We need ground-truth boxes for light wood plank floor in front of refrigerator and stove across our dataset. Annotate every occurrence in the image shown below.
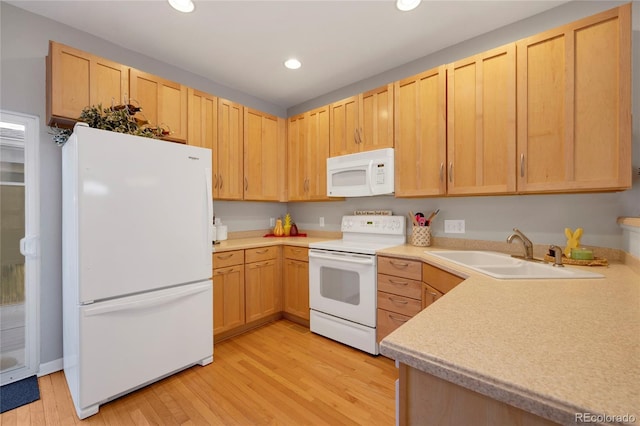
[0,320,398,426]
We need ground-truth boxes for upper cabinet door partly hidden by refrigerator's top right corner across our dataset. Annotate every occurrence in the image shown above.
[187,88,218,198]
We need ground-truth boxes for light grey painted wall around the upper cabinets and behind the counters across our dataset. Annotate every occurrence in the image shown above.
[0,1,640,363]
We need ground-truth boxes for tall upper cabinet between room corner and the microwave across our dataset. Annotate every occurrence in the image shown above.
[287,106,329,201]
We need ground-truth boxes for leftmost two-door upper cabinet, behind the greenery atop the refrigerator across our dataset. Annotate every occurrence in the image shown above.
[47,41,129,126]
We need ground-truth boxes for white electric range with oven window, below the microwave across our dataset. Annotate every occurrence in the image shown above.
[309,216,406,355]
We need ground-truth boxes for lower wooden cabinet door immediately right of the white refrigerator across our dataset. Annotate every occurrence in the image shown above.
[213,265,245,336]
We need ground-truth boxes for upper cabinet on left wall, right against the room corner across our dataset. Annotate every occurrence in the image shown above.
[244,107,286,201]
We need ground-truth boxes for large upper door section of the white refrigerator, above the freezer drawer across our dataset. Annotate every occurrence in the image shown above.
[63,126,213,303]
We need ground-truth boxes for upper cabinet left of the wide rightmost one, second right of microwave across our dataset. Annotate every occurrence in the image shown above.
[447,43,516,195]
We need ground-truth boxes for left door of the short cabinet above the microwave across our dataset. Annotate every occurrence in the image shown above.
[329,96,361,157]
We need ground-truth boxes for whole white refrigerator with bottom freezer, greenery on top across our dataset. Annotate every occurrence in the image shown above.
[62,123,213,419]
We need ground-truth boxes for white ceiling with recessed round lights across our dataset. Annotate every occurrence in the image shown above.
[7,0,588,108]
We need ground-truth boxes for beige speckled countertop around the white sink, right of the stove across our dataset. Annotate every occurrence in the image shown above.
[378,245,640,424]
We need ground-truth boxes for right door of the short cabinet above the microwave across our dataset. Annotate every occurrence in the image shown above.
[358,84,393,151]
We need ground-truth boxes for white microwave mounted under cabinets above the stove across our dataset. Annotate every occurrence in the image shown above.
[327,148,395,197]
